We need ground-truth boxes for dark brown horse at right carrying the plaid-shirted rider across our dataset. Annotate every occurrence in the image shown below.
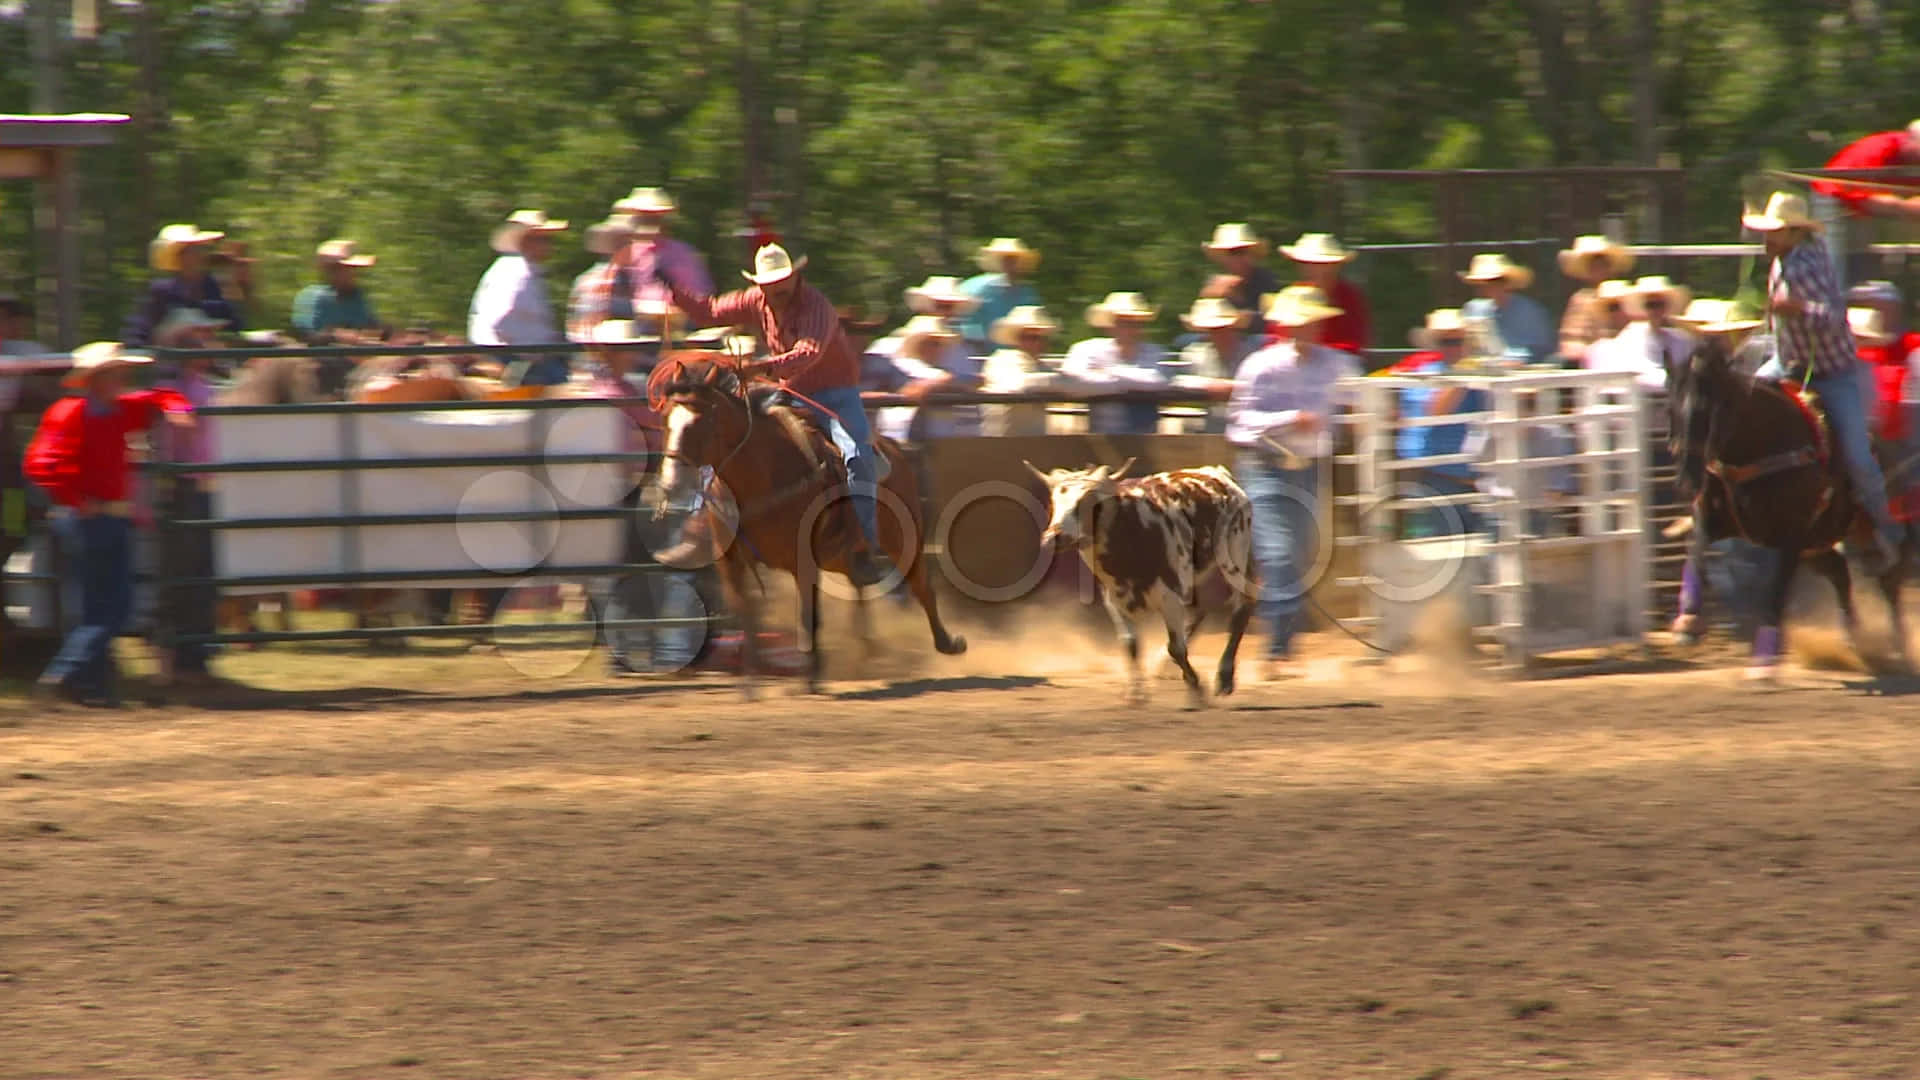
[1668,340,1910,676]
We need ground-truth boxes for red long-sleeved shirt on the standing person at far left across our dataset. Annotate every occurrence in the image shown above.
[21,390,192,507]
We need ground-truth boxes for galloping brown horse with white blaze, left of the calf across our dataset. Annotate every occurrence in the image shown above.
[647,352,966,696]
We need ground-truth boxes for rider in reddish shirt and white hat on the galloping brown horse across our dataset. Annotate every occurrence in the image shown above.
[666,244,893,586]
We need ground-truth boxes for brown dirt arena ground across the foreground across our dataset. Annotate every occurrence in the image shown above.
[0,611,1920,1080]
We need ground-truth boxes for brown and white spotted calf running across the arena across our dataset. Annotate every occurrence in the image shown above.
[1025,457,1260,707]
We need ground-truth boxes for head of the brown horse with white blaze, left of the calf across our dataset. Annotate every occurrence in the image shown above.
[647,352,751,511]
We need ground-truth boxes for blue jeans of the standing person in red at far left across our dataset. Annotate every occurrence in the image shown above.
[40,513,132,694]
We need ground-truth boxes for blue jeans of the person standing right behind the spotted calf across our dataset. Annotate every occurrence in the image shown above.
[1233,454,1319,659]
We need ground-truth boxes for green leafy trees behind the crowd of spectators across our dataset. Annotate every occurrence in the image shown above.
[0,0,1920,346]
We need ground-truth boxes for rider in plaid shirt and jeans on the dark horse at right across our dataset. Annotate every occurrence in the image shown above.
[1741,192,1901,577]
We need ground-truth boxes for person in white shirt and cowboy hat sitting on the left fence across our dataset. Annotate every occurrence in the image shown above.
[467,209,568,386]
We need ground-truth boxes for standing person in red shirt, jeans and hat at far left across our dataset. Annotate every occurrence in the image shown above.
[25,342,194,705]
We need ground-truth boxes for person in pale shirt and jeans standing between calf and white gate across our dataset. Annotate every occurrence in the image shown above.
[1227,284,1359,678]
